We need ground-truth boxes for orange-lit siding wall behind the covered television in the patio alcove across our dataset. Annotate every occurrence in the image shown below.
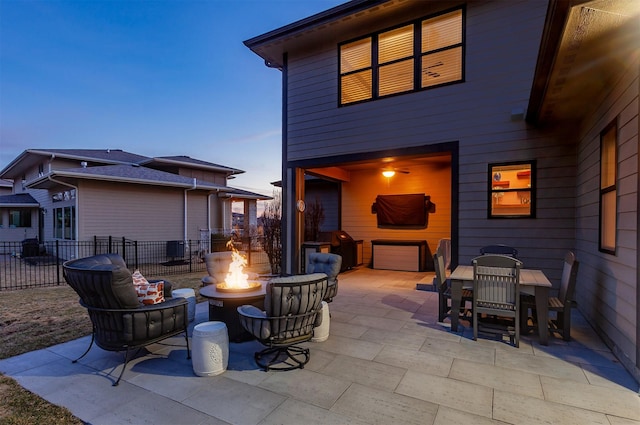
[342,161,451,264]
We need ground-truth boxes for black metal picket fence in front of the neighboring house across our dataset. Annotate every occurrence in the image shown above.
[0,237,269,291]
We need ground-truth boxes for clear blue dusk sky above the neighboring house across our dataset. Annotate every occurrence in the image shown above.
[0,0,346,195]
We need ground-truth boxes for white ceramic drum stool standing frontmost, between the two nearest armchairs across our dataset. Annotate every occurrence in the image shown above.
[191,322,229,376]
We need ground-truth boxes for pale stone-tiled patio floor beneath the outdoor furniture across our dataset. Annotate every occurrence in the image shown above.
[0,267,640,425]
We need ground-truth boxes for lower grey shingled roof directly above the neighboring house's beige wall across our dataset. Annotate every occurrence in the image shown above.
[28,164,232,192]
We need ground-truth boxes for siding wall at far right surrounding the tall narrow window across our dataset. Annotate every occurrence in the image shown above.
[576,55,640,380]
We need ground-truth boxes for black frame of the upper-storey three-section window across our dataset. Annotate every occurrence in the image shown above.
[337,5,467,107]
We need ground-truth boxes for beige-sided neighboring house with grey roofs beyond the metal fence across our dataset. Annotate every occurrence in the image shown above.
[0,149,270,247]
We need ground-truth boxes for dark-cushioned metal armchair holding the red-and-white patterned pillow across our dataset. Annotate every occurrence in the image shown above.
[63,254,191,386]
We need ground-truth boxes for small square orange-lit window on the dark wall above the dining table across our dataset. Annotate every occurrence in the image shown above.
[488,161,536,218]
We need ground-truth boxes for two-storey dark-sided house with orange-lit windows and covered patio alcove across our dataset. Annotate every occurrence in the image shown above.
[245,0,640,380]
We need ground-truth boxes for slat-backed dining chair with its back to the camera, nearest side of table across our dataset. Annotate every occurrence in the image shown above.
[472,254,522,347]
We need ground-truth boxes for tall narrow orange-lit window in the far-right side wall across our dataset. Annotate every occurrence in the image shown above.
[599,122,618,254]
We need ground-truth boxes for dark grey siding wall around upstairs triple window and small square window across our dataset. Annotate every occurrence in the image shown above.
[287,1,576,285]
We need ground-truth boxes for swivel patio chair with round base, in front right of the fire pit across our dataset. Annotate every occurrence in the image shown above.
[238,273,329,371]
